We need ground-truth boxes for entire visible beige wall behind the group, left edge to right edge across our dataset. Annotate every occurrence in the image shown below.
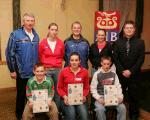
[0,0,150,88]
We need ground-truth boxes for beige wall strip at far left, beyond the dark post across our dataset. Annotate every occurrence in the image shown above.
[0,0,15,88]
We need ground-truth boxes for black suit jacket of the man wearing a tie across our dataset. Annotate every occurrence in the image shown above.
[114,37,145,74]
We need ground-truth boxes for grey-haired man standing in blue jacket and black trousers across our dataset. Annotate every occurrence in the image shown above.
[6,13,39,120]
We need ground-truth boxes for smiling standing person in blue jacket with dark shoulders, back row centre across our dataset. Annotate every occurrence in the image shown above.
[65,21,89,68]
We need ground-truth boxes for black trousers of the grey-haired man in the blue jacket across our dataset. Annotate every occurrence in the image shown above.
[16,75,28,119]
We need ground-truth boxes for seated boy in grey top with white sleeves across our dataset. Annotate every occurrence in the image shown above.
[90,56,126,120]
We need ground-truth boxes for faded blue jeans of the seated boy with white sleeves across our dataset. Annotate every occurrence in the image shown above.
[95,101,126,120]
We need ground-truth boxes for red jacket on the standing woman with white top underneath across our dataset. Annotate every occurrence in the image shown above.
[39,38,64,68]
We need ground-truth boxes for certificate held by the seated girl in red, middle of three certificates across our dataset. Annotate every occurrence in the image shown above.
[68,84,83,105]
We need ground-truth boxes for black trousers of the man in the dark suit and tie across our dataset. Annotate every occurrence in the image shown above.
[118,74,140,119]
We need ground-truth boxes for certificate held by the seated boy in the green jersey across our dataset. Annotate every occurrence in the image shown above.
[32,89,49,113]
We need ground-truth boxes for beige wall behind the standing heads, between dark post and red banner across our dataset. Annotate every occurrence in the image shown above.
[21,0,98,40]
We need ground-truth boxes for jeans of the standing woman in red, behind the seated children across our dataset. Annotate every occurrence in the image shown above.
[46,68,61,112]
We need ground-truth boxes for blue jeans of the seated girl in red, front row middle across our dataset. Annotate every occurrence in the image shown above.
[61,100,89,120]
